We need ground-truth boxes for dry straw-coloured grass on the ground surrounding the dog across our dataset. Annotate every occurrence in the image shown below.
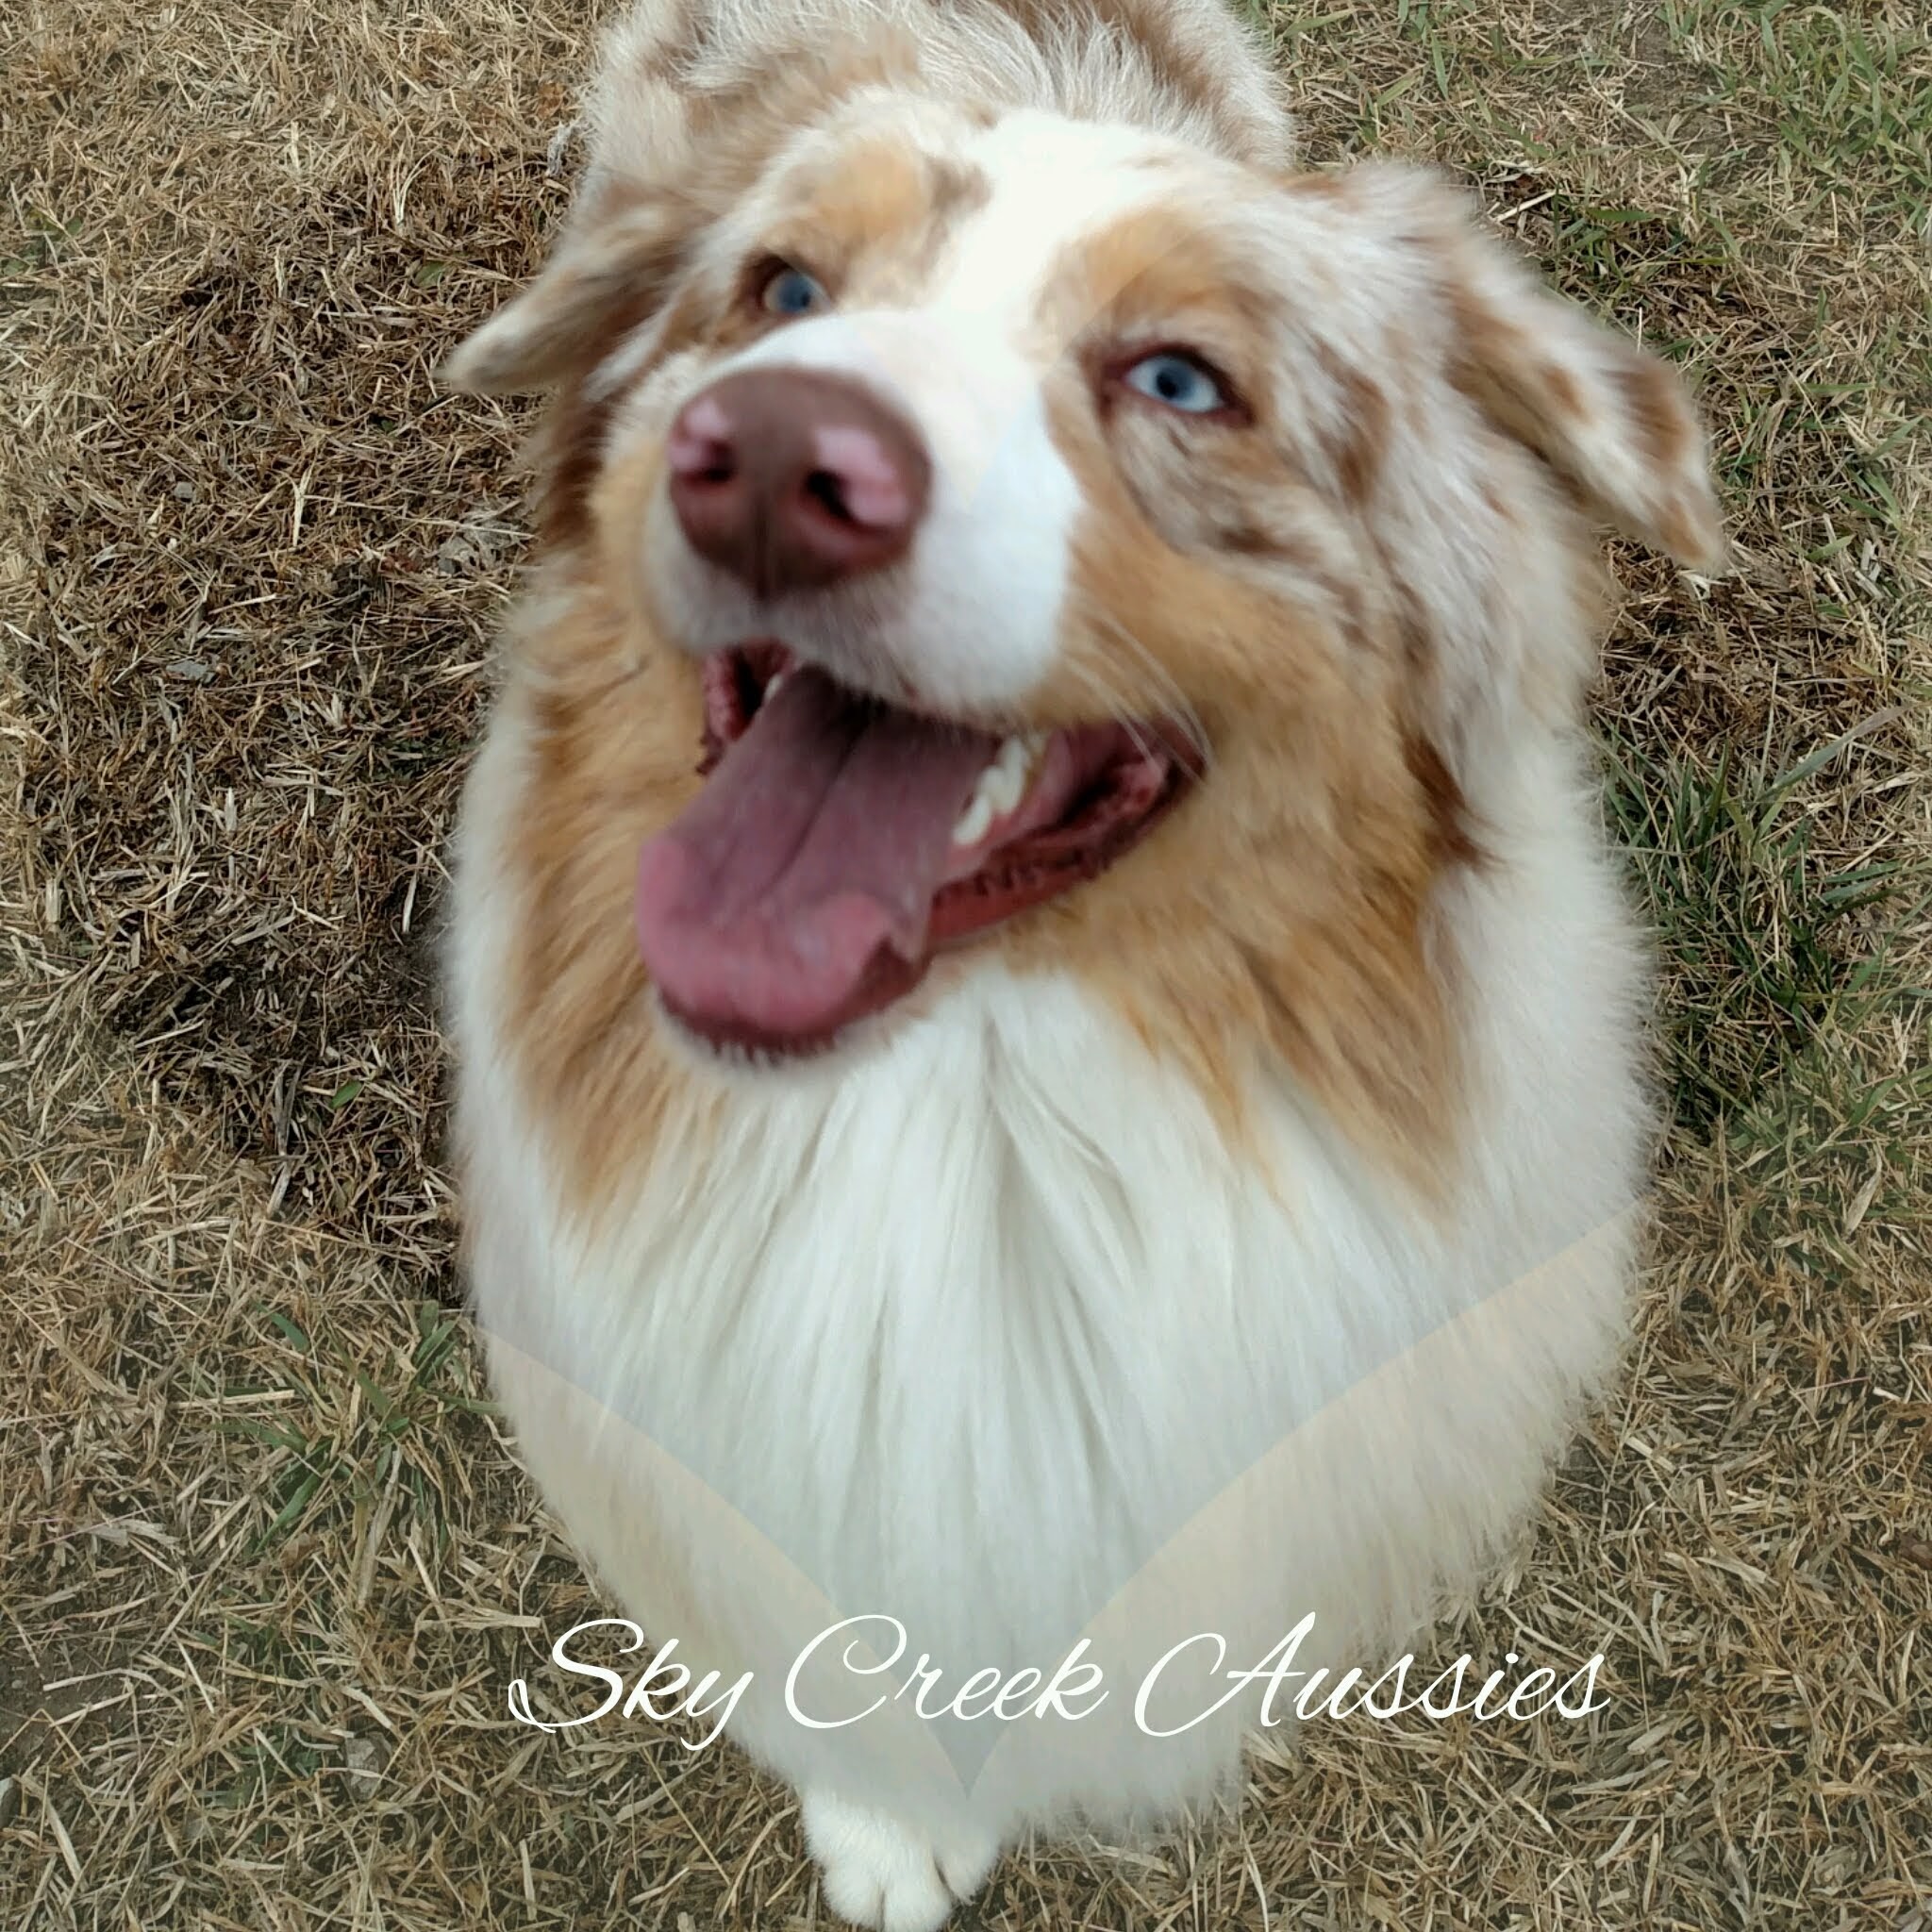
[0,0,1932,1932]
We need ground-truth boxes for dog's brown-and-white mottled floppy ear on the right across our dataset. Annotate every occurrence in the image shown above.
[1360,166,1725,572]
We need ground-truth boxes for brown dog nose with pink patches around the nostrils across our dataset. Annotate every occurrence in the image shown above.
[669,369,931,597]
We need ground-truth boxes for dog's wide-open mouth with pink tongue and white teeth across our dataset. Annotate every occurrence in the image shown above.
[638,643,1200,1053]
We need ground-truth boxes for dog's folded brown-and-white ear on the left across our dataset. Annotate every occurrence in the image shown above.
[437,197,693,396]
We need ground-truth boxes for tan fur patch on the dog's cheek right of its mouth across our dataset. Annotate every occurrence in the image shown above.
[1035,355,1471,1192]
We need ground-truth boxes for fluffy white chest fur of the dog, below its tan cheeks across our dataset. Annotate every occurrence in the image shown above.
[452,699,1641,1836]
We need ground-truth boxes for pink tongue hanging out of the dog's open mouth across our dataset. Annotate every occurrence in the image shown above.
[638,669,999,1047]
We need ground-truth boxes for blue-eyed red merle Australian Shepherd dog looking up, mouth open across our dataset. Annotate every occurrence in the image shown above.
[446,0,1724,1932]
